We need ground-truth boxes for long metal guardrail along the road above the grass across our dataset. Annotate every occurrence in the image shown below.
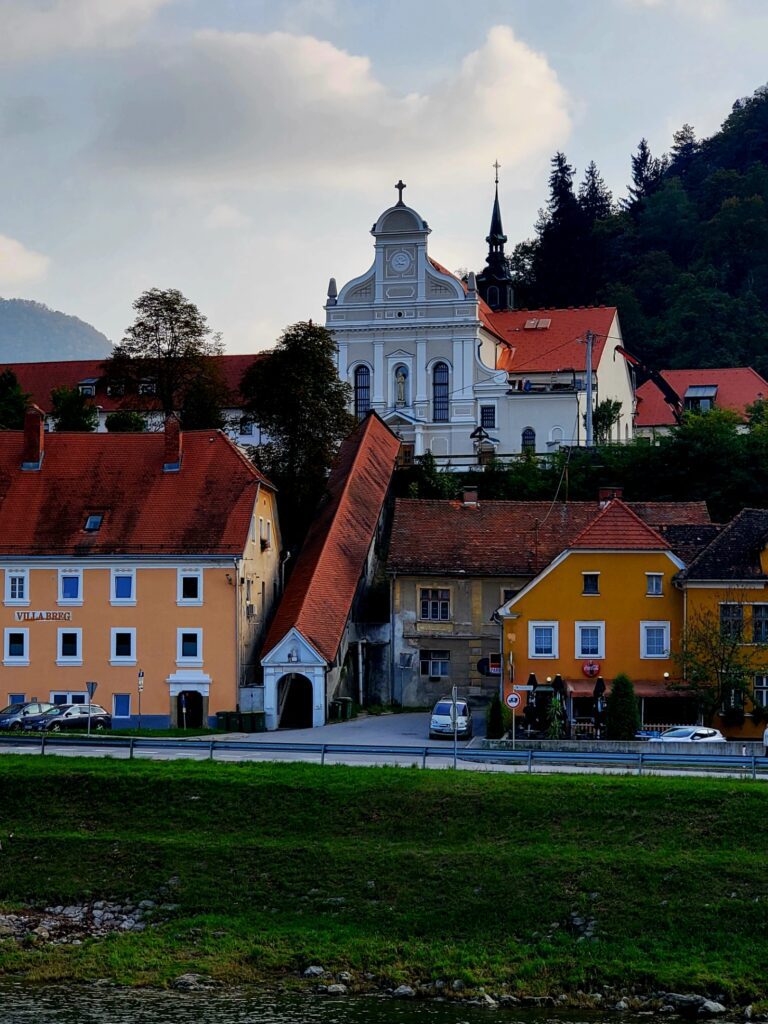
[0,733,768,779]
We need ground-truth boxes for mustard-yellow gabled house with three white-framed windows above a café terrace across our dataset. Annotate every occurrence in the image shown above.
[500,500,689,724]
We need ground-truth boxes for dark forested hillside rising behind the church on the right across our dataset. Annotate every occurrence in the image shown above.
[510,86,768,374]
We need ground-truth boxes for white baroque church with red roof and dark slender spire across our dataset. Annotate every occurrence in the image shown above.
[326,179,634,468]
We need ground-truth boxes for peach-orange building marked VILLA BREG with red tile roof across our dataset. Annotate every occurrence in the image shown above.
[0,408,280,728]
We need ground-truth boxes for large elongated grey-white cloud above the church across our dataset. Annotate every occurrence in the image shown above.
[91,26,570,188]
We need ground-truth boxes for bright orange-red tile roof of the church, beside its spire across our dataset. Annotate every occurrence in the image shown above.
[490,306,621,374]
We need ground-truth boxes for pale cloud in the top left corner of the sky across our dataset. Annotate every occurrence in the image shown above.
[0,0,172,62]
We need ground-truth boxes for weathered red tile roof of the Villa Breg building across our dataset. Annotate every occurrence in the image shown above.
[0,421,271,558]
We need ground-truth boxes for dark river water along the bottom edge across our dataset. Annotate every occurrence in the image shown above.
[0,984,581,1024]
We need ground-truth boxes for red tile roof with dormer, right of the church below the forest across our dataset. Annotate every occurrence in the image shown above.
[635,367,768,427]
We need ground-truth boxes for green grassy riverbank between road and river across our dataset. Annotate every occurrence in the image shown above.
[0,757,768,999]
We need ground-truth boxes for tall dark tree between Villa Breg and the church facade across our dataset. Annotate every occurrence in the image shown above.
[241,321,354,546]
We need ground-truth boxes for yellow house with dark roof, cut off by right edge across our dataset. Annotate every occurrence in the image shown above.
[678,509,768,738]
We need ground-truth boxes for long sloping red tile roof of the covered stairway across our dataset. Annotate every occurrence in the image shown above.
[263,413,400,663]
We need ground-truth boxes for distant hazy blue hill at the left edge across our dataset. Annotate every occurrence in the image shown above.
[0,299,112,365]
